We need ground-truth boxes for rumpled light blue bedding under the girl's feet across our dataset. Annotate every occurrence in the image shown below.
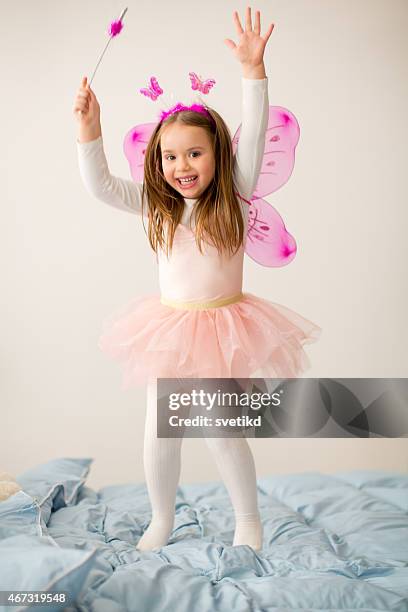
[0,459,408,612]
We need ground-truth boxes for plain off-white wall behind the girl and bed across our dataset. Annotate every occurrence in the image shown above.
[0,0,408,487]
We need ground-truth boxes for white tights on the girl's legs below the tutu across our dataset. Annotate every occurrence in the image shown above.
[137,380,262,550]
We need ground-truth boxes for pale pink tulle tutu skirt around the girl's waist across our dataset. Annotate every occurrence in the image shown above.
[99,293,321,389]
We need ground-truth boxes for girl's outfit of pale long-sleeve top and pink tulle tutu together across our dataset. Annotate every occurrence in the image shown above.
[77,78,321,389]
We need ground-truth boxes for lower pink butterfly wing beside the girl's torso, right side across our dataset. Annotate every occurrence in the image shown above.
[245,198,297,268]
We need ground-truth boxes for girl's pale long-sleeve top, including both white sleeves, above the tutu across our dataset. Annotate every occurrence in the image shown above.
[77,78,269,302]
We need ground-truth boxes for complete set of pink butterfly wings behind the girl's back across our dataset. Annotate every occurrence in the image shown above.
[123,106,300,268]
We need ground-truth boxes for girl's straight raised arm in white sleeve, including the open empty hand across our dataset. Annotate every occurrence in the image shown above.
[225,7,274,199]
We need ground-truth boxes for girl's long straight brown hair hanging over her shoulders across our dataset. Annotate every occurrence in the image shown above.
[142,106,244,257]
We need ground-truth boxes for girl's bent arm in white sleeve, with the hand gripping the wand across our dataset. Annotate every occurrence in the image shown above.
[73,77,147,215]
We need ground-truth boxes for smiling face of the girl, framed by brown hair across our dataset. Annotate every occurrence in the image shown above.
[160,123,215,198]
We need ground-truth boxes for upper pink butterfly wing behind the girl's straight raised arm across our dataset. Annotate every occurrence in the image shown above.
[232,106,300,198]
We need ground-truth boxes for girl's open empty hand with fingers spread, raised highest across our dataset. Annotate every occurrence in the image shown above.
[224,6,275,67]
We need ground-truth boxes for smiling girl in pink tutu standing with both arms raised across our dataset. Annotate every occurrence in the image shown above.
[74,7,320,551]
